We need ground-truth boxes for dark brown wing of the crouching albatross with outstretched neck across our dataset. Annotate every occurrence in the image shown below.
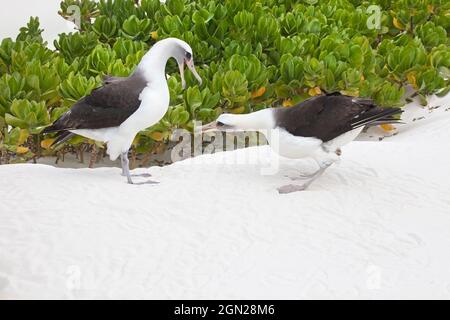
[275,93,402,142]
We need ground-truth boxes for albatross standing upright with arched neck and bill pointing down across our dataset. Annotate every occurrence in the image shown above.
[43,38,202,184]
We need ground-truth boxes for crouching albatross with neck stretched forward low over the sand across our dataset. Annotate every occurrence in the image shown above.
[201,93,402,193]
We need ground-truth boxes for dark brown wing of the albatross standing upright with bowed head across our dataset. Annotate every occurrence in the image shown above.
[43,74,147,133]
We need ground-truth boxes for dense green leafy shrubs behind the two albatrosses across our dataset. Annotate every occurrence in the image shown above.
[0,0,450,162]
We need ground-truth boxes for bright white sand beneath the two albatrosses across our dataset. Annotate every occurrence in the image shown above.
[0,98,450,299]
